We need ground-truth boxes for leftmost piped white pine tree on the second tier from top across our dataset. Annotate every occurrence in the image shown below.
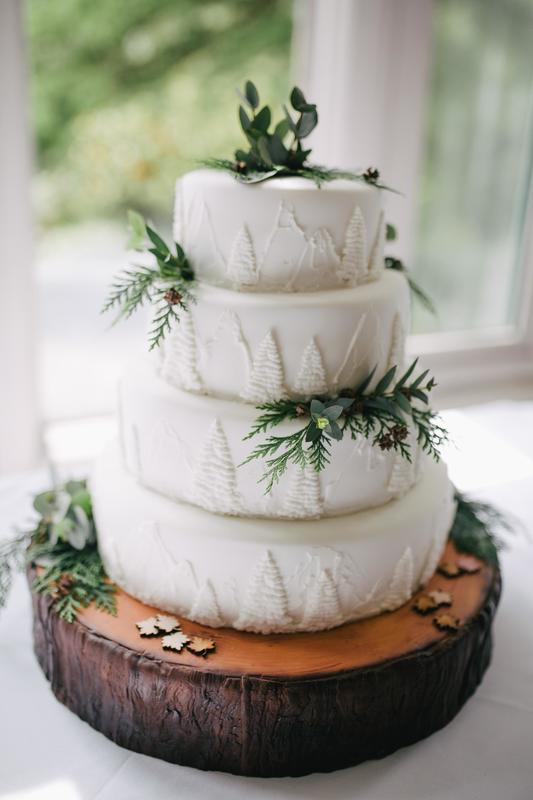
[161,312,202,392]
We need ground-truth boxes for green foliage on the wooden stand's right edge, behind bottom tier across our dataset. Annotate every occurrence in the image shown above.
[450,490,512,566]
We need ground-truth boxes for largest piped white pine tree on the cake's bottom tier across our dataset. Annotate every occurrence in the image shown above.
[235,550,292,633]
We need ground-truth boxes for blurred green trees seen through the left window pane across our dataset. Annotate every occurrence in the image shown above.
[26,0,292,227]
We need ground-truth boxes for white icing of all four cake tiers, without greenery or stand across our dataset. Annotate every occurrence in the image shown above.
[91,169,454,633]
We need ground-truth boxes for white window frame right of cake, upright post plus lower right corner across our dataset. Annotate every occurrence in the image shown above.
[294,0,533,406]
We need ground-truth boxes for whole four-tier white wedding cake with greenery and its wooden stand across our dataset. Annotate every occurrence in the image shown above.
[19,82,501,777]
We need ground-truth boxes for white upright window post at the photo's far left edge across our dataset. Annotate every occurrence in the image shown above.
[0,0,40,474]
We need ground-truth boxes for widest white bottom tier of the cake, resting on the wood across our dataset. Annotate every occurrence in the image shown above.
[91,446,455,633]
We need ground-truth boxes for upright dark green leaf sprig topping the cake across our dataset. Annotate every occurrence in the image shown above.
[202,81,395,191]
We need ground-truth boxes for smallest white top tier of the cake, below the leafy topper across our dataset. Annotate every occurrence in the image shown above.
[174,169,385,292]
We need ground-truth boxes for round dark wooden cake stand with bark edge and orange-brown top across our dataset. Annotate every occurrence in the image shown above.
[33,544,500,776]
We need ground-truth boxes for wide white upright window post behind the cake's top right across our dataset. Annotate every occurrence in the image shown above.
[295,0,433,258]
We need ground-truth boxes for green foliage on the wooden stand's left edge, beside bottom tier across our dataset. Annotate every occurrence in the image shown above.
[0,481,116,622]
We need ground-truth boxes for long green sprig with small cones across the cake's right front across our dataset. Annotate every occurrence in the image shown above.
[242,359,447,493]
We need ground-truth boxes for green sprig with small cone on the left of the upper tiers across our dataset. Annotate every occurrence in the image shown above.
[102,211,194,350]
